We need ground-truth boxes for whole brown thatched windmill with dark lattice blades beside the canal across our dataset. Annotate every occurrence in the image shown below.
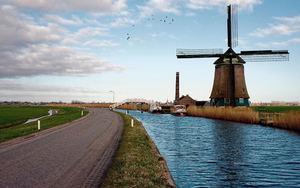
[176,5,289,107]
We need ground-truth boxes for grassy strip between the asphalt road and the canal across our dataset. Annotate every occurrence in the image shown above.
[100,113,173,188]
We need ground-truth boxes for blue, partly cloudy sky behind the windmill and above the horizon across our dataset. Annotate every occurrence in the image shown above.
[0,0,300,103]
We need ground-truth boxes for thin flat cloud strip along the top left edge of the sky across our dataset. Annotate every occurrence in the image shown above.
[0,0,127,12]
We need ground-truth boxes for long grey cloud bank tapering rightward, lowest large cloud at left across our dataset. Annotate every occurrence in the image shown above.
[0,44,125,78]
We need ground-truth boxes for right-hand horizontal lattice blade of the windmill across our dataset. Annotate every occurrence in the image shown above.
[237,50,289,62]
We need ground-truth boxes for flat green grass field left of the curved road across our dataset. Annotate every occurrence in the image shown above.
[0,106,88,143]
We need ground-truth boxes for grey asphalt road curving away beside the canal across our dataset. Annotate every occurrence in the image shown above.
[0,108,124,188]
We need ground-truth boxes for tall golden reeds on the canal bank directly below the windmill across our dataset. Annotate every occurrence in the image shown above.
[187,106,260,123]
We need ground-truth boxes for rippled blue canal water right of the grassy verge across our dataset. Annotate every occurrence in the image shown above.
[118,111,300,187]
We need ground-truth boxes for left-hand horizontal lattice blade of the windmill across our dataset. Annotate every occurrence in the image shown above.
[176,49,223,58]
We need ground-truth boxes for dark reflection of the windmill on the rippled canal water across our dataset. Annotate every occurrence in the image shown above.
[213,121,247,187]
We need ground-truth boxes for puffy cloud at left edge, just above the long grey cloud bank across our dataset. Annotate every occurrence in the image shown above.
[0,5,68,51]
